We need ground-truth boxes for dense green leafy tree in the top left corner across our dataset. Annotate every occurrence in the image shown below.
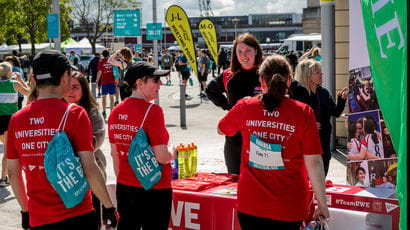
[0,0,71,55]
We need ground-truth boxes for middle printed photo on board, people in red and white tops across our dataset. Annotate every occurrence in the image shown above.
[347,110,385,161]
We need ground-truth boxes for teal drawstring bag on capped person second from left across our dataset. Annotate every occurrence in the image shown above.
[128,104,162,190]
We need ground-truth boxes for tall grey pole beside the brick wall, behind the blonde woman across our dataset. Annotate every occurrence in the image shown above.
[320,0,336,150]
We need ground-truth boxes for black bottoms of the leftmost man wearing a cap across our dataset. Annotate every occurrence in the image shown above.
[30,211,98,230]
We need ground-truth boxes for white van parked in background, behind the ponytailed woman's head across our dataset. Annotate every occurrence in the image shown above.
[276,33,322,53]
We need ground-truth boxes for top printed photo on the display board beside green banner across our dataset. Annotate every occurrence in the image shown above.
[347,66,379,113]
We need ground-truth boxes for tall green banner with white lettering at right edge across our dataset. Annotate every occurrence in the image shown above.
[362,0,407,229]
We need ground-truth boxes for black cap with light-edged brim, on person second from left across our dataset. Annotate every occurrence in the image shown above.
[124,61,171,87]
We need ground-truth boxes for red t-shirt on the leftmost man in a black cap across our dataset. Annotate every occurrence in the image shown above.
[7,98,93,226]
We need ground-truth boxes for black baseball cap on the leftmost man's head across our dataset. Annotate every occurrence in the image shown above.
[33,50,73,80]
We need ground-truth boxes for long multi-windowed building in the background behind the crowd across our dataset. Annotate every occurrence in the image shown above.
[72,13,303,48]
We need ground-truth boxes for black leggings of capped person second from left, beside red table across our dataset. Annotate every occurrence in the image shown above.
[116,184,172,230]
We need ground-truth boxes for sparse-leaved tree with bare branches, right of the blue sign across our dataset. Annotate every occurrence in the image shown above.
[70,0,141,53]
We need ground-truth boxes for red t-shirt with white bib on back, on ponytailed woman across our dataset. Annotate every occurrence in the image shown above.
[218,97,322,221]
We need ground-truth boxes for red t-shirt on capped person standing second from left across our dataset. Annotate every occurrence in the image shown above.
[108,97,172,189]
